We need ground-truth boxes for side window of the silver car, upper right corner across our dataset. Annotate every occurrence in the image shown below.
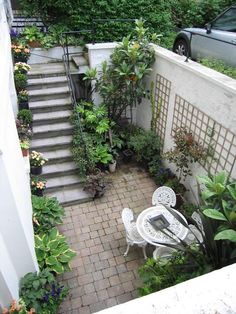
[212,8,236,32]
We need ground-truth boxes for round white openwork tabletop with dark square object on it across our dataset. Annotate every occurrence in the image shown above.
[136,204,188,246]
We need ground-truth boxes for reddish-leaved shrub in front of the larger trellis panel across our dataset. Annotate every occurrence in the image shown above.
[163,128,207,180]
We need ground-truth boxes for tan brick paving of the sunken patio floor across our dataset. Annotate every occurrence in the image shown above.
[59,165,156,314]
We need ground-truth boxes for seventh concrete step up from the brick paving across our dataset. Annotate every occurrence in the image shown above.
[33,110,72,126]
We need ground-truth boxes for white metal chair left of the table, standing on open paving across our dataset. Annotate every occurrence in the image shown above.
[122,208,147,259]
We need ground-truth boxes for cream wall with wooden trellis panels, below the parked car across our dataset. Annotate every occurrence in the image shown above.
[137,45,236,199]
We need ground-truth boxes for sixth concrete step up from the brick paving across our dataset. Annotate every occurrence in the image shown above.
[33,122,73,139]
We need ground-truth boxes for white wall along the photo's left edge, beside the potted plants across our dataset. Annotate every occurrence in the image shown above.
[0,0,38,307]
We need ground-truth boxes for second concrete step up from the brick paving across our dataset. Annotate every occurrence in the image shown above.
[47,174,84,192]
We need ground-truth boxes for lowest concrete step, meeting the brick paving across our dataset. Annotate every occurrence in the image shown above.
[45,187,93,207]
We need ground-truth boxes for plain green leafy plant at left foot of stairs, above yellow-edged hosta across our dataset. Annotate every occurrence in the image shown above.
[32,195,65,234]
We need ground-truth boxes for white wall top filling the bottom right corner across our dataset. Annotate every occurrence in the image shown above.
[98,264,236,314]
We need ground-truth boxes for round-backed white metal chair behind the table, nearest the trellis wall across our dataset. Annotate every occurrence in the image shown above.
[152,186,176,207]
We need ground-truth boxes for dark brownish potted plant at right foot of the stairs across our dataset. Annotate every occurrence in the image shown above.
[84,168,106,199]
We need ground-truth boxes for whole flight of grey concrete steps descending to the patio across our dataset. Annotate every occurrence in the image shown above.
[28,62,92,206]
